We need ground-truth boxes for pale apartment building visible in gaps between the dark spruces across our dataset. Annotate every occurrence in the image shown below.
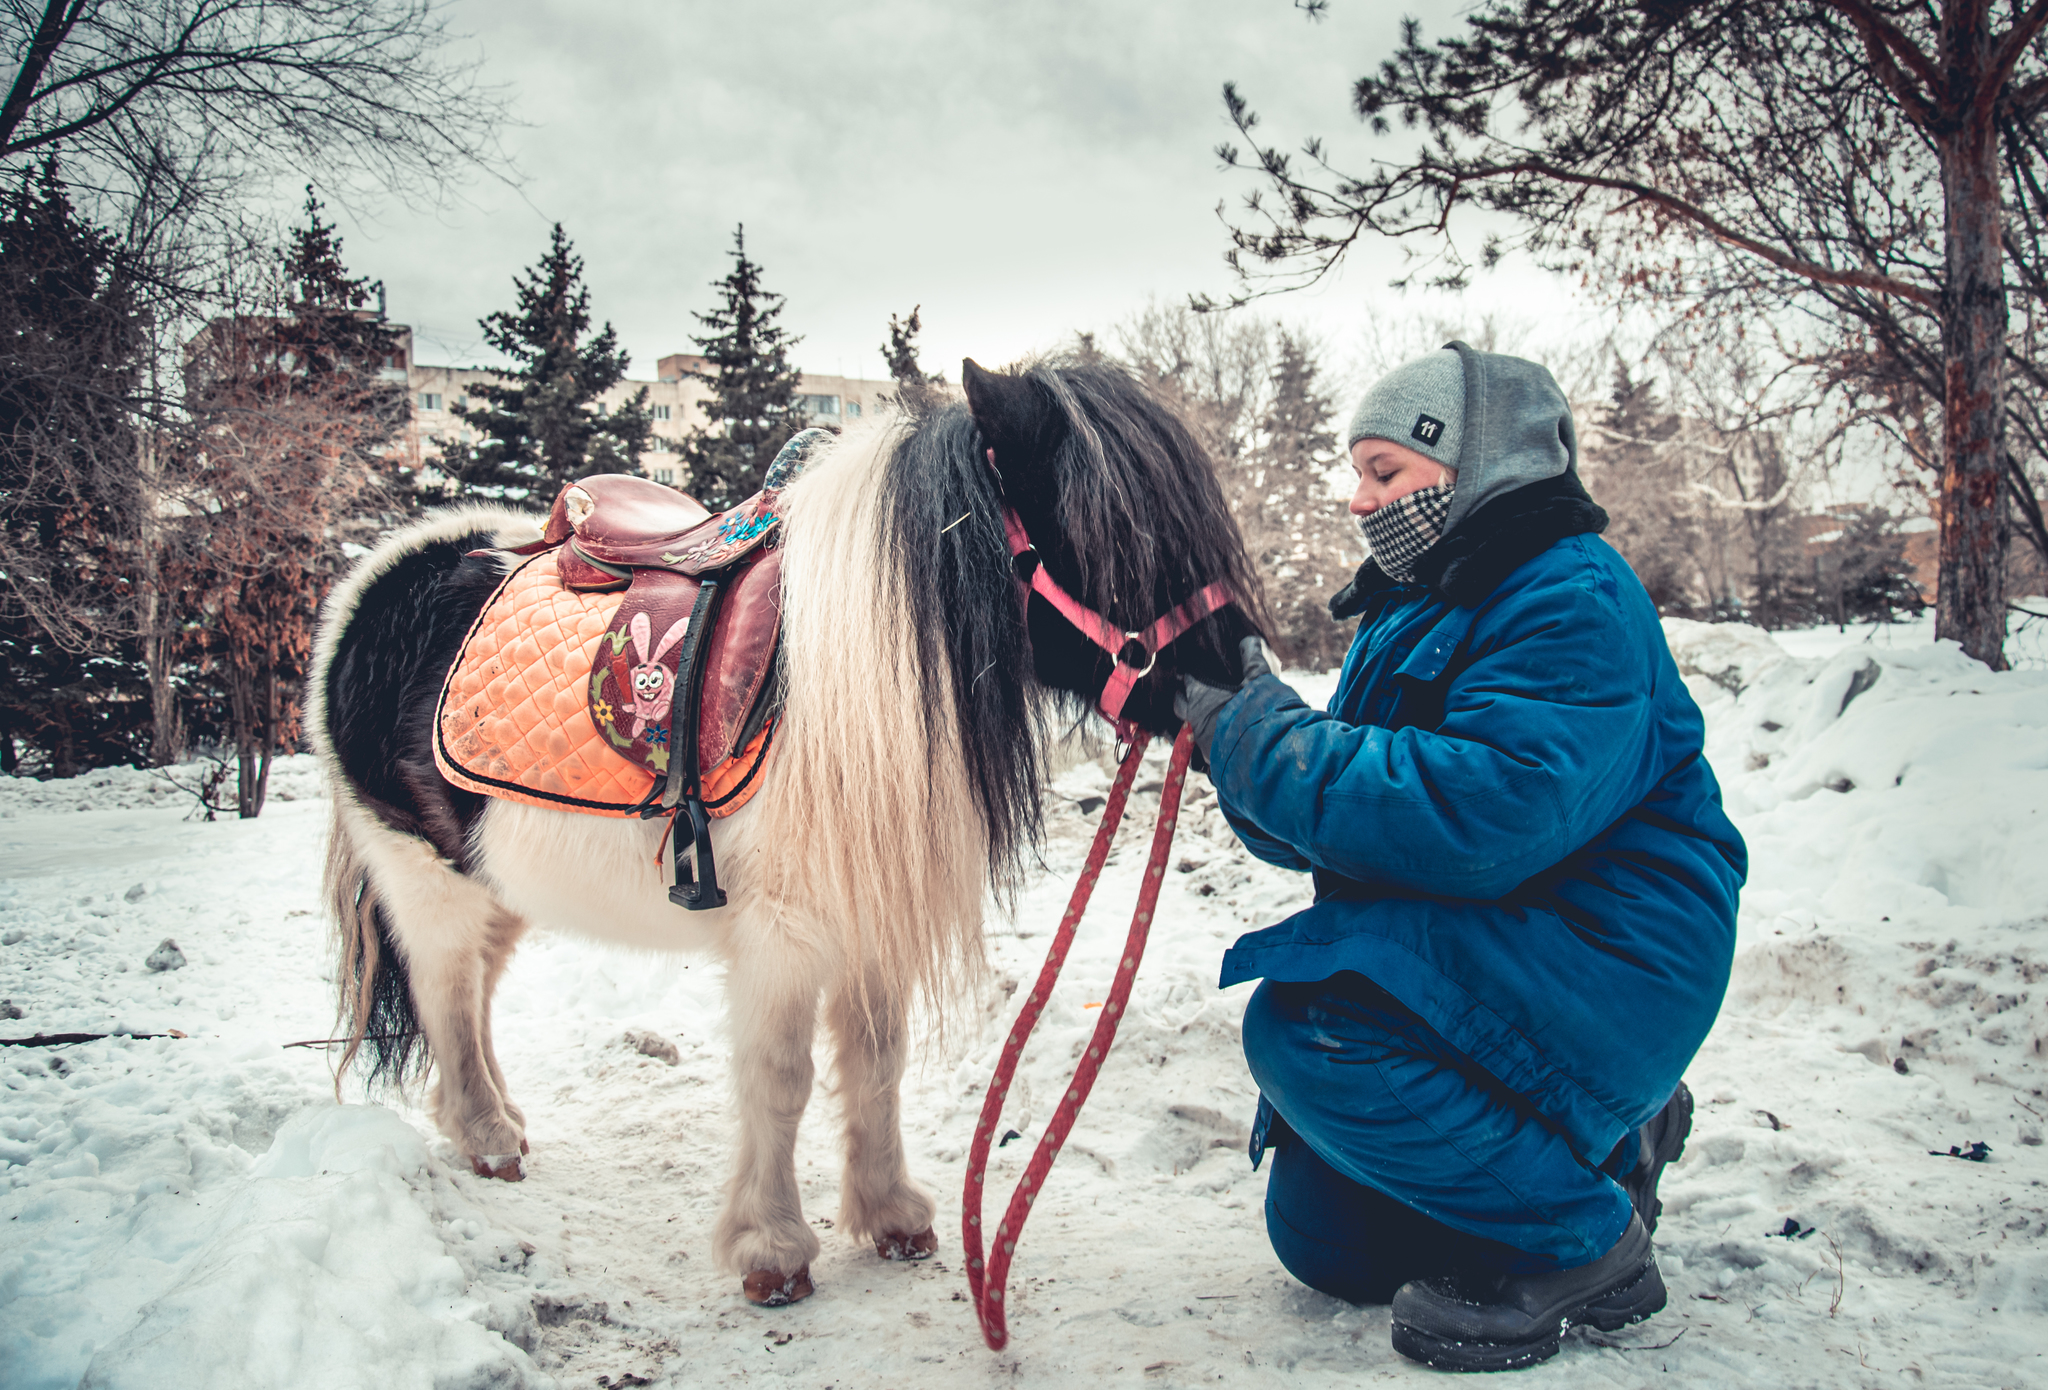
[391,328,895,487]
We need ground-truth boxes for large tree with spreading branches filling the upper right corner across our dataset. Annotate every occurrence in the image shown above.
[1221,0,2048,665]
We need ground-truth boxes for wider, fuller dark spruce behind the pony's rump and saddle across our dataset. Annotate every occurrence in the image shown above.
[438,223,653,504]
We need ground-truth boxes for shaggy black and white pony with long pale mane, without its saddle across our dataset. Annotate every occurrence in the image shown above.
[309,360,1260,1302]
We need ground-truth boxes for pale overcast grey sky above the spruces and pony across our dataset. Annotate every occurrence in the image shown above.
[327,0,1597,391]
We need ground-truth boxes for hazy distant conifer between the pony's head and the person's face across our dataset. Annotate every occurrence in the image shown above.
[1225,328,1364,667]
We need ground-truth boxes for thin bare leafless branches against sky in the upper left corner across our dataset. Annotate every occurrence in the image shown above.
[0,0,502,217]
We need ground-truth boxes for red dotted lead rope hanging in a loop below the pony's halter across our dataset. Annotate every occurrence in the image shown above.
[961,727,1190,1351]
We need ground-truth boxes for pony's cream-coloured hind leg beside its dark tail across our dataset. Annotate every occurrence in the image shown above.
[362,827,526,1181]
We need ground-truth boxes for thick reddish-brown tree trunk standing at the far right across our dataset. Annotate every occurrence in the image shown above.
[1933,0,2007,671]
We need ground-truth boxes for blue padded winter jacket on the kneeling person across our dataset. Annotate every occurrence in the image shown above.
[1210,345,1747,1163]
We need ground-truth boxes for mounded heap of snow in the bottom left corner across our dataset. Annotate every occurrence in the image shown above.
[0,1089,545,1390]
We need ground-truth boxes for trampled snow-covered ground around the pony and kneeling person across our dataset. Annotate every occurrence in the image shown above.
[0,622,2048,1390]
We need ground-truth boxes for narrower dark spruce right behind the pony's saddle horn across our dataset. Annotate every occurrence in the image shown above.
[682,225,807,512]
